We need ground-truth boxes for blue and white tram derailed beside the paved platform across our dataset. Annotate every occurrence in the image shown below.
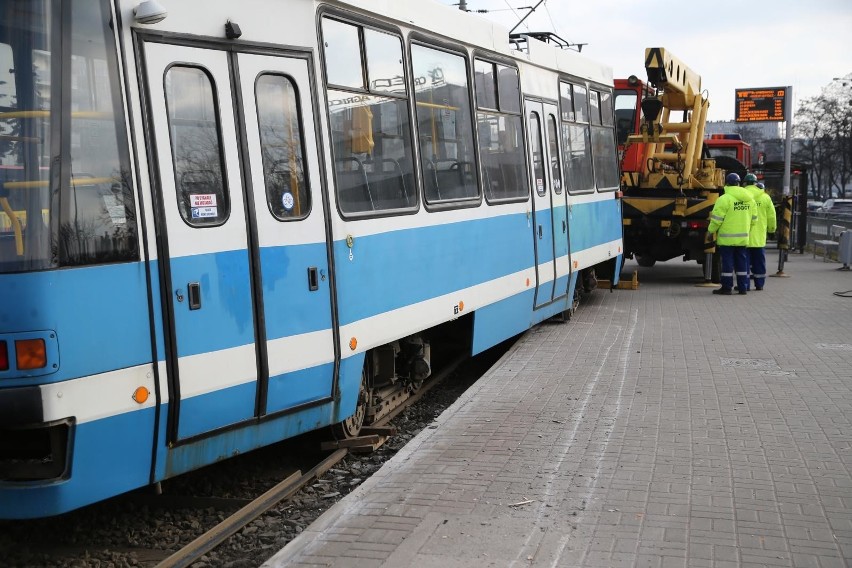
[0,0,622,519]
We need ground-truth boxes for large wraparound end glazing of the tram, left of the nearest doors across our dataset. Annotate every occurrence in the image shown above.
[0,0,139,272]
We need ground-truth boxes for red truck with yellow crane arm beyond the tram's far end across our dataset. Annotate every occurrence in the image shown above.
[615,47,750,272]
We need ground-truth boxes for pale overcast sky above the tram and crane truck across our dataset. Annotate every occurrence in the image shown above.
[438,0,852,120]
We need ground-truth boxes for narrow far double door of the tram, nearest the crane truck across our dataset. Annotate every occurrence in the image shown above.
[525,99,570,307]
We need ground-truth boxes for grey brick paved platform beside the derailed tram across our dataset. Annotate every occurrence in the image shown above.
[264,255,852,568]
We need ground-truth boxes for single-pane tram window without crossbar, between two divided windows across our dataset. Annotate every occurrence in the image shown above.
[411,45,479,203]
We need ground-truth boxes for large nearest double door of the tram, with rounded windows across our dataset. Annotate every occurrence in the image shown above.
[144,43,334,441]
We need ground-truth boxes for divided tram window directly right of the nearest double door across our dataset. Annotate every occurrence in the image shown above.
[322,18,417,215]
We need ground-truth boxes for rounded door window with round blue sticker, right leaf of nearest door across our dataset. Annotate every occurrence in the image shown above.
[255,74,311,221]
